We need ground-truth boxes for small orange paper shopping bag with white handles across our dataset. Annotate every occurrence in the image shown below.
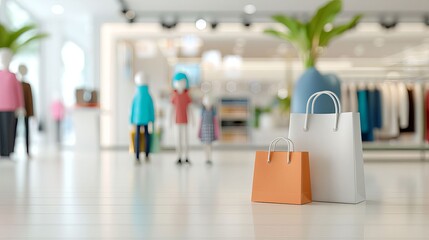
[252,137,311,204]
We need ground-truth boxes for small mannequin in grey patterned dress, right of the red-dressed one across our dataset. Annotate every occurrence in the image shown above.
[198,95,219,165]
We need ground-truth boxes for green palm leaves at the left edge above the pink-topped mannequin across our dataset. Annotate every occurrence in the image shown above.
[0,23,48,54]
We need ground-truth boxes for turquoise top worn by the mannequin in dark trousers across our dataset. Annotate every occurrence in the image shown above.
[130,85,155,126]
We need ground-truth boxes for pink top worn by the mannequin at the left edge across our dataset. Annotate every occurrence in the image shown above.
[0,70,24,112]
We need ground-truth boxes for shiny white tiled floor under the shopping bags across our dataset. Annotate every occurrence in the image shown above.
[0,151,429,240]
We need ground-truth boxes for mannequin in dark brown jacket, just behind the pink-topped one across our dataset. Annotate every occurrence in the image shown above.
[15,64,34,157]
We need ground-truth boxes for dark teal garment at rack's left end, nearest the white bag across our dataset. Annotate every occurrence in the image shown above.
[357,90,374,141]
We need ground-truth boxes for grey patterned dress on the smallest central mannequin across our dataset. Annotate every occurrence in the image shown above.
[198,107,219,144]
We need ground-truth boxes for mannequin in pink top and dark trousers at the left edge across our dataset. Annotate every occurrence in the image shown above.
[0,48,25,157]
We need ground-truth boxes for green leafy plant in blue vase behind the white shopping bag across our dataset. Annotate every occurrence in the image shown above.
[265,0,362,113]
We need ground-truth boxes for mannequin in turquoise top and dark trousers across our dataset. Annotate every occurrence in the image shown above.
[130,71,155,162]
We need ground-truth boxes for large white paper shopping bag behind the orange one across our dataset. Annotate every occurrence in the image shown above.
[289,91,365,203]
